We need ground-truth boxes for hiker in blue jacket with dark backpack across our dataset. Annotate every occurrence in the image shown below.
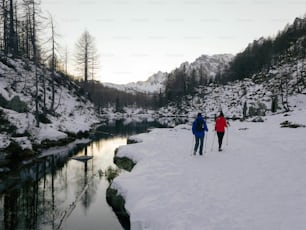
[192,113,208,155]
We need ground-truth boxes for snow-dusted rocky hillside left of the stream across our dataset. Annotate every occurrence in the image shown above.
[0,58,98,159]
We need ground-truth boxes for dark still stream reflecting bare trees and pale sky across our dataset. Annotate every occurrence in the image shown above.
[0,118,184,230]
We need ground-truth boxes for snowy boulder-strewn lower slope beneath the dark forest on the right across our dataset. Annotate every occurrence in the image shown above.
[158,56,306,118]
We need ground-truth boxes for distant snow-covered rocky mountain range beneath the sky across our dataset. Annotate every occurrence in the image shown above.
[103,54,234,93]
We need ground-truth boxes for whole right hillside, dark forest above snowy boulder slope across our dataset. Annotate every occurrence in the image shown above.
[155,18,306,118]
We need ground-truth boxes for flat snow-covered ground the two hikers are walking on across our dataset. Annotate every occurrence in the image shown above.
[112,109,306,230]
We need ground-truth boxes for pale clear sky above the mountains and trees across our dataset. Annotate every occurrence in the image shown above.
[42,0,306,84]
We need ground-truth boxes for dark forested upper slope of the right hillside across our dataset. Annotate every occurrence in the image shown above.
[216,18,306,82]
